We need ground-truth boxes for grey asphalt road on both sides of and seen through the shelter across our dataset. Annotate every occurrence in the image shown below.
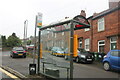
[2,51,120,78]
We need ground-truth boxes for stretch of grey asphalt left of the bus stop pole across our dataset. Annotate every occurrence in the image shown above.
[2,51,32,76]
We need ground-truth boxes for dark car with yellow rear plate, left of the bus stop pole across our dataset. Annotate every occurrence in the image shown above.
[10,47,26,58]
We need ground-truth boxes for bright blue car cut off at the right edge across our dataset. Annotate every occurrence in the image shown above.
[103,50,120,71]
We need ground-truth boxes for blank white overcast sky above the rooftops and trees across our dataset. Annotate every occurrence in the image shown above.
[0,0,109,39]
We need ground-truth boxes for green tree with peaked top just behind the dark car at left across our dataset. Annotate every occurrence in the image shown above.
[7,33,21,47]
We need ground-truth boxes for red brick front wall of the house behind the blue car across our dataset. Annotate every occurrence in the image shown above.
[92,11,118,53]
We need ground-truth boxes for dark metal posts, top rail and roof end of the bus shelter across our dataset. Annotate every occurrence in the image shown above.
[37,15,90,80]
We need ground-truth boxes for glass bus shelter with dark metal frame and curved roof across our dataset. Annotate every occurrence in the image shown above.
[37,15,90,79]
